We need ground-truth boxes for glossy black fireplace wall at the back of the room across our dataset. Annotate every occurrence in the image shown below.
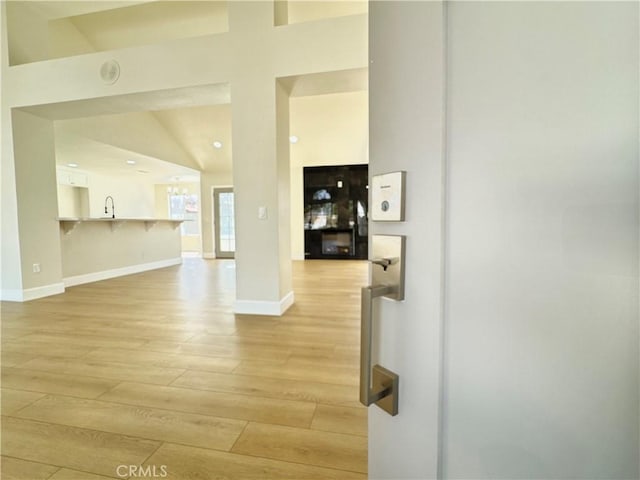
[304,165,369,259]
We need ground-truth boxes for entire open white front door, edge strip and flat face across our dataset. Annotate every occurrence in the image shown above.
[369,2,640,479]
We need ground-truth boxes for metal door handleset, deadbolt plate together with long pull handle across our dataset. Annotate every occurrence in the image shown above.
[360,235,405,415]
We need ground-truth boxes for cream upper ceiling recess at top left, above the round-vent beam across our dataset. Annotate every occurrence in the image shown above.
[8,1,227,65]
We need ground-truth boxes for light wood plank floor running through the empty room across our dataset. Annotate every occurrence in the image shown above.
[1,258,367,480]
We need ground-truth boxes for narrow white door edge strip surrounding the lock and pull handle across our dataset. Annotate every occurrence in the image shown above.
[369,1,443,479]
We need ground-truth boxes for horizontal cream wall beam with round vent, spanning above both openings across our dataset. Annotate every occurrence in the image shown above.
[3,9,366,114]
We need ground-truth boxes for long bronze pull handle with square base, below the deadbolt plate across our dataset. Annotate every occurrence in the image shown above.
[360,284,399,415]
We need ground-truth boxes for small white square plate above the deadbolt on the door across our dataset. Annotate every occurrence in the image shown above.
[370,171,406,222]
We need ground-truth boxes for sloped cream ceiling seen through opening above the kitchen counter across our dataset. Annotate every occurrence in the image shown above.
[56,104,231,183]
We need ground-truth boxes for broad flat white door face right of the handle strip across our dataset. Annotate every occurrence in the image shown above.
[443,2,640,479]
